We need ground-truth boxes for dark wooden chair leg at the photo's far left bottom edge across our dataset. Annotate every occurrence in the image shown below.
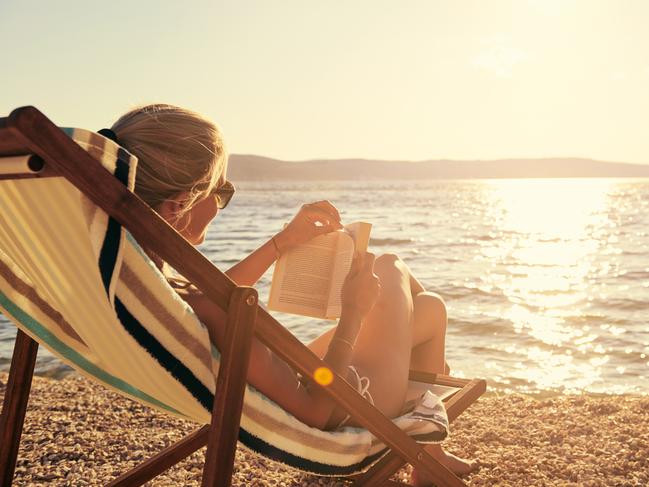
[0,329,38,486]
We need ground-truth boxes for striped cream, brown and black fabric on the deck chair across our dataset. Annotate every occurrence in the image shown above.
[0,129,449,476]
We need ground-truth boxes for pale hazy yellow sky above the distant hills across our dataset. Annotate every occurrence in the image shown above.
[0,0,649,164]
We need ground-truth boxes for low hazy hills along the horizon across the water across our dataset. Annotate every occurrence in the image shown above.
[228,154,649,181]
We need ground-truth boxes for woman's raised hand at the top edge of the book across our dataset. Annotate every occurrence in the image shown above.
[274,201,343,252]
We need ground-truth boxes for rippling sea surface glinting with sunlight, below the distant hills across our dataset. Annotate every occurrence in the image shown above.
[0,179,649,394]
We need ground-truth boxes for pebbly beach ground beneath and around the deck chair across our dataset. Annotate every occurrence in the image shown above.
[0,373,649,486]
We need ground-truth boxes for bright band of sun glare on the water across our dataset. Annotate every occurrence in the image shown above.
[474,179,623,396]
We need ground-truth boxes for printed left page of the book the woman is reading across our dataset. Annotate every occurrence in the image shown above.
[268,232,342,318]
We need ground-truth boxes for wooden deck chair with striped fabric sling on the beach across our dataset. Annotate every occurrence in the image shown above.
[0,107,486,486]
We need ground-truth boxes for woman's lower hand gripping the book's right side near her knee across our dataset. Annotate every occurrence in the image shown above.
[342,252,381,320]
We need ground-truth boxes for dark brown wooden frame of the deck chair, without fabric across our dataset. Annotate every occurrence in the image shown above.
[0,107,486,487]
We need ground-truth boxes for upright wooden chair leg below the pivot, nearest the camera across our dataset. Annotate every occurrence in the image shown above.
[202,287,257,487]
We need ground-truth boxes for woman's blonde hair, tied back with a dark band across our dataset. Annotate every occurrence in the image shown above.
[112,104,228,223]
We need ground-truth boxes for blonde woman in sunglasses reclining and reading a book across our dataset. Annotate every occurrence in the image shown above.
[107,105,474,485]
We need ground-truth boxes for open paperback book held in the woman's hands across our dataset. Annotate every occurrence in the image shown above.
[268,222,372,319]
